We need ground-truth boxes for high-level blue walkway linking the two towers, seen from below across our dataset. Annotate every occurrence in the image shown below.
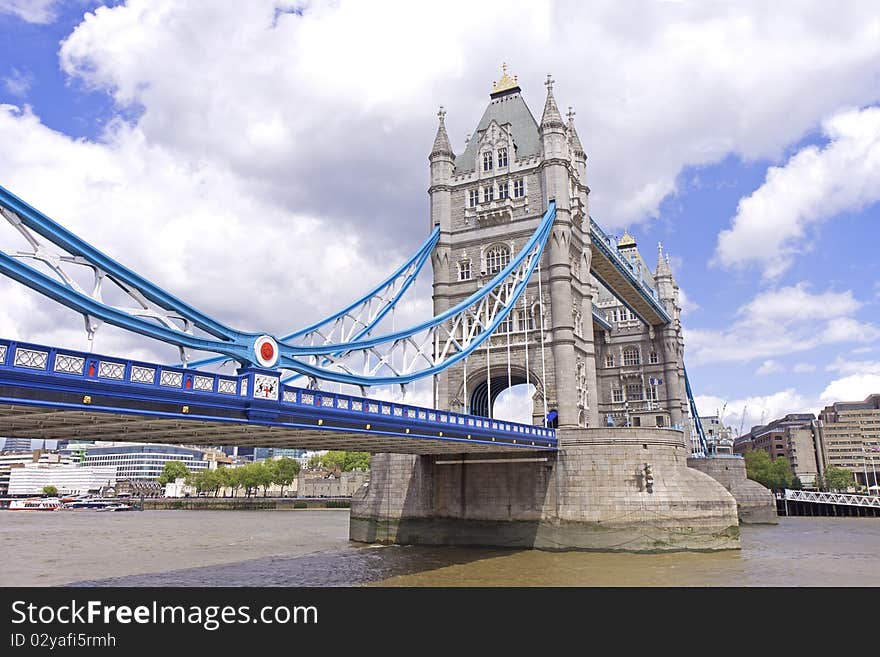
[590,217,672,326]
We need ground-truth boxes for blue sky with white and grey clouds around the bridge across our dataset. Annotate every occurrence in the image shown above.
[0,0,880,440]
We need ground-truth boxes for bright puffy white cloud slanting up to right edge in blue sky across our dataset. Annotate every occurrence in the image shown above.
[716,107,880,277]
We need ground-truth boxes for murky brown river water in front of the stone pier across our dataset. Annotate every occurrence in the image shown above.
[0,509,880,586]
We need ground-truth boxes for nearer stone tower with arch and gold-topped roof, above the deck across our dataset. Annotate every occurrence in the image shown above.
[428,67,599,427]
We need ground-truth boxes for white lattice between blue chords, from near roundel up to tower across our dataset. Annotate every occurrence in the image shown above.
[292,234,544,378]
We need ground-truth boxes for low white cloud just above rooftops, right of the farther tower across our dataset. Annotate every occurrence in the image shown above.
[694,388,818,436]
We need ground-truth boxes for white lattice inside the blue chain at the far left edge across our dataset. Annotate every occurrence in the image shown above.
[0,207,193,362]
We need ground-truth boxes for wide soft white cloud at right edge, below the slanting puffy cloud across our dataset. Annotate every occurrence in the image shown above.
[685,282,880,364]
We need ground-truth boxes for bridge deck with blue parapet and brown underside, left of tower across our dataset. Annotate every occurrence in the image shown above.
[0,341,556,454]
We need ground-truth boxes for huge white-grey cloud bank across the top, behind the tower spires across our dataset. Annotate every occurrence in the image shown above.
[53,0,880,228]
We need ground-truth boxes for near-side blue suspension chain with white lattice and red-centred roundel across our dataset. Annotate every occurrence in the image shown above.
[0,179,556,386]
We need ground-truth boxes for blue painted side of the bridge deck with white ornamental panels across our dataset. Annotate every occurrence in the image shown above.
[0,340,557,450]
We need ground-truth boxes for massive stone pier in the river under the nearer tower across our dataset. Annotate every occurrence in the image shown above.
[350,428,740,552]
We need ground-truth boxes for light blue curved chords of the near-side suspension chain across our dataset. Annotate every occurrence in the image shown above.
[0,182,556,386]
